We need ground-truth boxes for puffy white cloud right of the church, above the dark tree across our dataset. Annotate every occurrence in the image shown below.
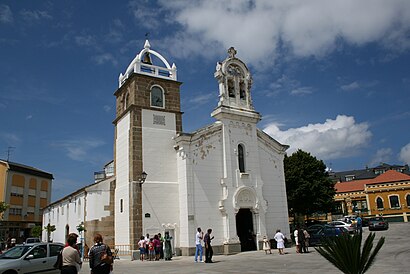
[264,115,372,160]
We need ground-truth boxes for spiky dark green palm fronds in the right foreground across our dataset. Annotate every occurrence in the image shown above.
[315,233,385,274]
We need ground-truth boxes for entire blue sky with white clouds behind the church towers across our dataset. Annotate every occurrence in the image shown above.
[0,0,410,201]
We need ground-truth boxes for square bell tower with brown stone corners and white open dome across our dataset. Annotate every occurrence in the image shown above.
[113,40,182,250]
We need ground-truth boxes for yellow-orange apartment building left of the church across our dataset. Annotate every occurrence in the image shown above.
[0,160,53,243]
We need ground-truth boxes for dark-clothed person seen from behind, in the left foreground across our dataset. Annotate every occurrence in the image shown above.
[88,233,113,274]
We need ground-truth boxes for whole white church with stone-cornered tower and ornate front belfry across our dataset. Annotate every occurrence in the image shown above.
[43,40,289,255]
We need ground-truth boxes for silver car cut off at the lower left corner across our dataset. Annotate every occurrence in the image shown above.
[0,243,64,274]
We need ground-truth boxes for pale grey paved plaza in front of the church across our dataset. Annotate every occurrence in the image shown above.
[80,223,410,274]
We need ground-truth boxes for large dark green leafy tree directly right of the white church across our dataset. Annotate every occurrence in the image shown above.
[284,149,335,219]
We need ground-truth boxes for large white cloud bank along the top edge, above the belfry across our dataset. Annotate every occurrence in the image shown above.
[153,0,410,65]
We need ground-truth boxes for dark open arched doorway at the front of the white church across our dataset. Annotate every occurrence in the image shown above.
[236,208,256,251]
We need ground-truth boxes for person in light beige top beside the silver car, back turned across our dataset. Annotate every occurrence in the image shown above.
[60,233,82,274]
